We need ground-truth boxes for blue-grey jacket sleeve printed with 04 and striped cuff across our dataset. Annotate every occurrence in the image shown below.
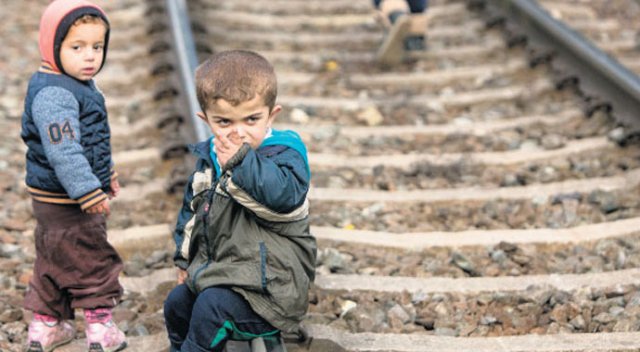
[31,87,107,210]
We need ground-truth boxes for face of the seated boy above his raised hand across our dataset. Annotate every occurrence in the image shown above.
[198,95,282,149]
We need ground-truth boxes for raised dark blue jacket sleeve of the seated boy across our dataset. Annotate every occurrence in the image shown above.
[227,146,310,214]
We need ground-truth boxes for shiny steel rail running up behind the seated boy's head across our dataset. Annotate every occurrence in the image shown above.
[166,0,211,141]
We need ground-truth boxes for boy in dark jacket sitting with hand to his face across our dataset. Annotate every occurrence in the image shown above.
[164,51,316,352]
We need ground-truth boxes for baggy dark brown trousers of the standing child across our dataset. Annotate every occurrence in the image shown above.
[24,200,123,319]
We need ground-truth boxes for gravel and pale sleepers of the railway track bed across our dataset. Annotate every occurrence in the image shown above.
[0,0,640,351]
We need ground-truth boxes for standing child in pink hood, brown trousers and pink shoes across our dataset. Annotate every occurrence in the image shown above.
[21,0,126,352]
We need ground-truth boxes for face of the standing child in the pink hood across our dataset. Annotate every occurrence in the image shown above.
[60,22,107,81]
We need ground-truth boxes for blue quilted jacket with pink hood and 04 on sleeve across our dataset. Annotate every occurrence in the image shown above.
[21,0,115,209]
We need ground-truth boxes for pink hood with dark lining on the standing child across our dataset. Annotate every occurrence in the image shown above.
[38,0,109,73]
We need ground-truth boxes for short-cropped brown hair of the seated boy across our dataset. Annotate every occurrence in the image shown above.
[196,50,278,113]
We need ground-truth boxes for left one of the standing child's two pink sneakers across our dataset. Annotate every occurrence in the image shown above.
[25,320,76,352]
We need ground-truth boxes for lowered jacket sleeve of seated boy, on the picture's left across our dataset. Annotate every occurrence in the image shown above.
[173,172,195,269]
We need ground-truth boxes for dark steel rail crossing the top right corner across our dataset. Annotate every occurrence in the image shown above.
[476,0,640,136]
